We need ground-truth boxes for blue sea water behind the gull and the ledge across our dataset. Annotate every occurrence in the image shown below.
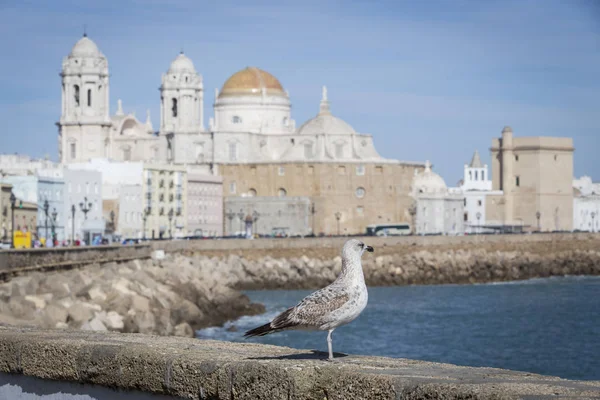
[198,277,600,380]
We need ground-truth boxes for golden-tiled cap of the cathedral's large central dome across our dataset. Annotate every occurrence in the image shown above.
[219,67,287,97]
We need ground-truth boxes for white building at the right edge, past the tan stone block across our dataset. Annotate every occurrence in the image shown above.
[573,176,600,232]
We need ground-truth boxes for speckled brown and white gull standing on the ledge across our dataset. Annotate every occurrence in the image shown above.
[244,239,373,360]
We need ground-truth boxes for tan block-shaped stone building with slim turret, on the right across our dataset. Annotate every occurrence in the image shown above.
[486,126,574,231]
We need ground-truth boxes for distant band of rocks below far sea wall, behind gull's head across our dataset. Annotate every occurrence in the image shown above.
[186,240,600,289]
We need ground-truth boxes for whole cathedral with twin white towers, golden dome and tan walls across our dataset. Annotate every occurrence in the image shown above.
[57,35,425,234]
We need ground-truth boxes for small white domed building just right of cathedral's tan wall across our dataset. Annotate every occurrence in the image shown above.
[412,161,464,235]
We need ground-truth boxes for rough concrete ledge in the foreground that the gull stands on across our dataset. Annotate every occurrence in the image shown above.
[0,327,600,400]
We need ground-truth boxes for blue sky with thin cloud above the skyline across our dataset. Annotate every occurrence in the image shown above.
[0,0,600,185]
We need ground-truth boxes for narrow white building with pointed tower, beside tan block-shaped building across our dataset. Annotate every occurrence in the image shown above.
[460,150,502,233]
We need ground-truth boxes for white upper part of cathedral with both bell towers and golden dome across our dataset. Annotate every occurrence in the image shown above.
[58,36,422,170]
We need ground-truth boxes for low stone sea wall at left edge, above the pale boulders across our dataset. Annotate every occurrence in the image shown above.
[0,244,151,275]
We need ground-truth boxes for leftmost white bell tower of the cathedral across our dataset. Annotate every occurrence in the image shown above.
[57,34,111,163]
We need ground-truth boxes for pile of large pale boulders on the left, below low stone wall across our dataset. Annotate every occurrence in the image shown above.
[0,255,264,337]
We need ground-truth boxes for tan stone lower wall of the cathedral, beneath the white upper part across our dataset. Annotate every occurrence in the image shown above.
[219,163,422,234]
